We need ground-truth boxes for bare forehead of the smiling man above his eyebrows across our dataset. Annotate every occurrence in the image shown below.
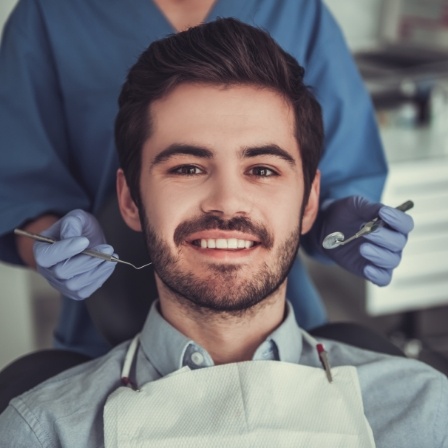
[149,84,299,158]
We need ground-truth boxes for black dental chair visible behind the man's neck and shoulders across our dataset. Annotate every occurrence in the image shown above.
[0,195,405,413]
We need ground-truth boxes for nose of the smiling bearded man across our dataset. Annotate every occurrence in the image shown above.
[201,173,253,219]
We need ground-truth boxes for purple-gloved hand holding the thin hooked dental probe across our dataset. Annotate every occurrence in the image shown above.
[33,210,117,300]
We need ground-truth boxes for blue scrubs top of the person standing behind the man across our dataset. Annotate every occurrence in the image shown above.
[0,0,387,356]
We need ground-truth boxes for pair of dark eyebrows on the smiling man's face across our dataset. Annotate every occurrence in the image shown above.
[151,143,296,168]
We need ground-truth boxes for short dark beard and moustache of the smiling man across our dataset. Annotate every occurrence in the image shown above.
[142,210,301,315]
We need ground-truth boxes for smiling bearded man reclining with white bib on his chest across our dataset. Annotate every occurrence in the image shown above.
[0,19,448,448]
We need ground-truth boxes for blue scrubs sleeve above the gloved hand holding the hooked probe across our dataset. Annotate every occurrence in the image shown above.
[0,1,89,264]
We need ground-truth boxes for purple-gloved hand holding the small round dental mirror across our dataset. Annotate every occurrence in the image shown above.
[317,196,414,286]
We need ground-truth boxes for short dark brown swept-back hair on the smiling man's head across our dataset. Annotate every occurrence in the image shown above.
[115,18,323,205]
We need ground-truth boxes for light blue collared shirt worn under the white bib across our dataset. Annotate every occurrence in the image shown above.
[0,304,448,448]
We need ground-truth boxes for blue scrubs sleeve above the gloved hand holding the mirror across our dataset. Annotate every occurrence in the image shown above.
[303,1,387,256]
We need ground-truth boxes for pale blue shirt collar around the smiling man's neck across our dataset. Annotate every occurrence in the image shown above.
[140,300,302,376]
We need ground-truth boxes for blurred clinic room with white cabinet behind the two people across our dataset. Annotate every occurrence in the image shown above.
[0,0,448,374]
